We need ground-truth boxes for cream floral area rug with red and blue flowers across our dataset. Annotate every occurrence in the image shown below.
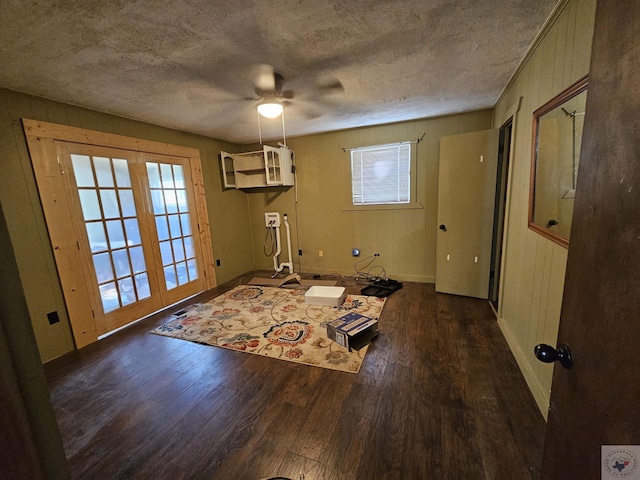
[151,285,385,373]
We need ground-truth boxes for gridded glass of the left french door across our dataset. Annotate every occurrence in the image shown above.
[71,154,151,313]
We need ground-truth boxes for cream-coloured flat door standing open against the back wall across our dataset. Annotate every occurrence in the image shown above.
[436,129,500,298]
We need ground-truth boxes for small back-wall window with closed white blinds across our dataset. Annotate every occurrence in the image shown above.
[351,142,411,205]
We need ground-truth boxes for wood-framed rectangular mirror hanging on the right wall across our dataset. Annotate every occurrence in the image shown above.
[529,76,588,247]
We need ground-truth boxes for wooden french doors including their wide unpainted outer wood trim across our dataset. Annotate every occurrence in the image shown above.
[22,119,216,348]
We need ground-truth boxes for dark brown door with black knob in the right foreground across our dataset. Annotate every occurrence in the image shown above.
[540,1,640,480]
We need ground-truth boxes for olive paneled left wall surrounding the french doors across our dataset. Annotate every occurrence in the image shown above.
[0,90,253,361]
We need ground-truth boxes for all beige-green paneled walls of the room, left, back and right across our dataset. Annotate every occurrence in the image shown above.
[0,4,595,415]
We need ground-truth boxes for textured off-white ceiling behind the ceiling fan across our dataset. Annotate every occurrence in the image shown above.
[0,0,556,143]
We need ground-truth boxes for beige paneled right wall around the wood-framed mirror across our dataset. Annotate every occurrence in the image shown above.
[494,0,596,417]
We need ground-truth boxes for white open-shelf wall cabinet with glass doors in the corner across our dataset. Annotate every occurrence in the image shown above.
[220,145,295,188]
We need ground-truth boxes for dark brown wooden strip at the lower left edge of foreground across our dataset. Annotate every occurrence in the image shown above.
[0,205,69,479]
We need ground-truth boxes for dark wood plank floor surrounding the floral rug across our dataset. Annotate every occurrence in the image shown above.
[46,274,545,480]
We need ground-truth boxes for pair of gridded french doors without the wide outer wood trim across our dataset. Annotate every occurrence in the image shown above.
[56,142,204,335]
